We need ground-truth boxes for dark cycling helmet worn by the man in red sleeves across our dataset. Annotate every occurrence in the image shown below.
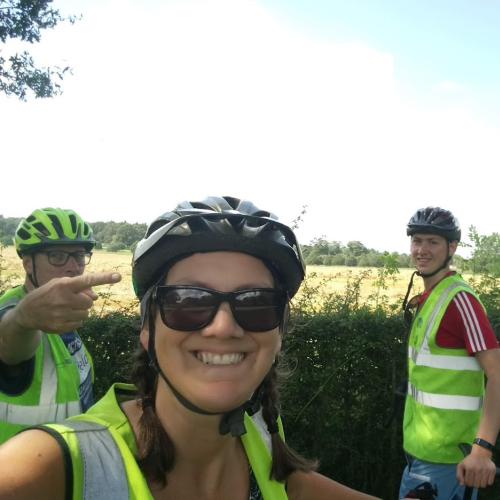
[406,207,461,241]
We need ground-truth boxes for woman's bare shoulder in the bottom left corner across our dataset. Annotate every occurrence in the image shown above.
[0,429,65,500]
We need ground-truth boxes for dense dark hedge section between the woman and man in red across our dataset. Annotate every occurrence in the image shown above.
[283,309,405,498]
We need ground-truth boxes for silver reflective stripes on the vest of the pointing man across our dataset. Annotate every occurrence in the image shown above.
[0,334,81,425]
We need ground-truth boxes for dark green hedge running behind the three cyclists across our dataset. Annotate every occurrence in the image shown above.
[81,276,500,500]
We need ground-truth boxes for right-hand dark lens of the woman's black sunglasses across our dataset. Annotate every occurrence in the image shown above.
[233,290,286,332]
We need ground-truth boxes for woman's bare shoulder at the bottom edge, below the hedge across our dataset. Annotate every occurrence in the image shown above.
[287,471,376,500]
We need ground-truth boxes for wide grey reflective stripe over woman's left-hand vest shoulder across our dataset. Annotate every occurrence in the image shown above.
[64,420,129,500]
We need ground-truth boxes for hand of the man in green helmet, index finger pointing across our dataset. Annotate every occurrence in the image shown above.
[16,272,121,333]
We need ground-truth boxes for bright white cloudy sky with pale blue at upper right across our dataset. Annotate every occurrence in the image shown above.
[0,0,500,252]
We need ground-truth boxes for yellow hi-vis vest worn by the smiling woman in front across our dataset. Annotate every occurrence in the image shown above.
[44,384,288,500]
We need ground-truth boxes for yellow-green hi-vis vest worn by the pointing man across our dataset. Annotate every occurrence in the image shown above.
[0,286,81,444]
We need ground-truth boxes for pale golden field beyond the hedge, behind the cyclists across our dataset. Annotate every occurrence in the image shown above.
[0,246,420,311]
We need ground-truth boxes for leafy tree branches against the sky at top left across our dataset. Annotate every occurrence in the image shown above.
[0,0,75,100]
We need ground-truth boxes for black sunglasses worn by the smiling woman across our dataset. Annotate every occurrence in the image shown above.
[153,285,288,332]
